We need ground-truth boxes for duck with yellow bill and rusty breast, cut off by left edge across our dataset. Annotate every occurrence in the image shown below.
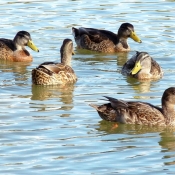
[0,31,39,62]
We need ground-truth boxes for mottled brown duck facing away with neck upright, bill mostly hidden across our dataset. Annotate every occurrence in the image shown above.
[32,39,77,85]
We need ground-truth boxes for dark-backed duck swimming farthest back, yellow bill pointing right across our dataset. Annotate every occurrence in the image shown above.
[72,23,142,53]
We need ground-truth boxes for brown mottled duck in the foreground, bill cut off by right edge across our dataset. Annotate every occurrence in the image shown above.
[90,87,175,126]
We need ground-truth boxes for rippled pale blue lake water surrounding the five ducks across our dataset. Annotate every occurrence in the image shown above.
[0,0,175,175]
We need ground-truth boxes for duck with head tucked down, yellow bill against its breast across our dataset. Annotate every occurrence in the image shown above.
[122,52,163,80]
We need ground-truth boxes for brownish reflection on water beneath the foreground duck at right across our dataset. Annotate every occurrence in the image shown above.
[96,120,175,165]
